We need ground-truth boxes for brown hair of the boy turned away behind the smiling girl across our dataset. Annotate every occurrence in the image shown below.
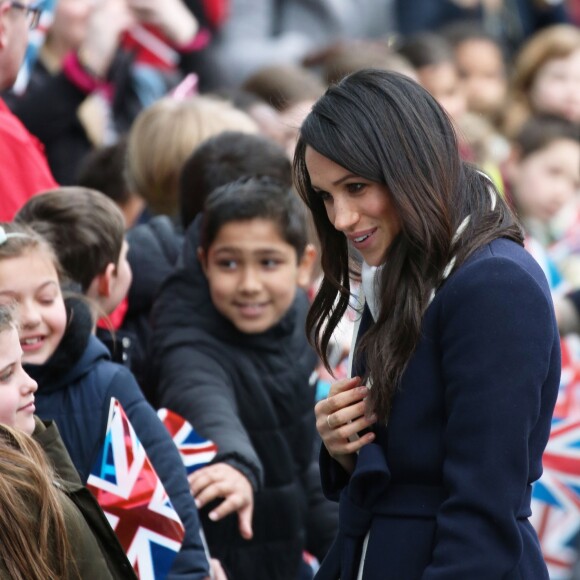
[15,187,125,292]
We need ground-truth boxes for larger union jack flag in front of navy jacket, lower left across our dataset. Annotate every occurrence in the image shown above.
[87,399,185,580]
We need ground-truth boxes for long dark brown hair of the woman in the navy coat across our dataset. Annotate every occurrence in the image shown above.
[294,69,522,419]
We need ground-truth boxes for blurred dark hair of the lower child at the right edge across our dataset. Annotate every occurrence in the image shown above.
[514,115,580,158]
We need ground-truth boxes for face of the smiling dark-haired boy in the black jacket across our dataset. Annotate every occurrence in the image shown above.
[198,219,311,334]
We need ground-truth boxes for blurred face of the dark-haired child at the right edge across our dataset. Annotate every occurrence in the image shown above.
[511,139,580,223]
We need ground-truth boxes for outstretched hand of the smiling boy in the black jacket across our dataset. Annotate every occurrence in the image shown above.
[188,463,254,540]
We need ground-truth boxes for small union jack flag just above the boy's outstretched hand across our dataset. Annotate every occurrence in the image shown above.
[157,409,217,475]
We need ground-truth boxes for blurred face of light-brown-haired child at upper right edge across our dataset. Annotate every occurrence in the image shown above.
[530,49,580,123]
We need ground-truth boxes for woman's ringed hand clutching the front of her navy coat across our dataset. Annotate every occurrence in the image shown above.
[314,377,377,473]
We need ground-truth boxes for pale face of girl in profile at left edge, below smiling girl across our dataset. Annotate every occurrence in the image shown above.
[0,328,38,435]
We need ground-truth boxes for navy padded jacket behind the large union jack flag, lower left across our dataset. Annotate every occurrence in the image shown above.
[25,299,209,580]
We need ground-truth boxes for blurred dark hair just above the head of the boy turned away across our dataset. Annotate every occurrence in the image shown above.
[76,137,131,206]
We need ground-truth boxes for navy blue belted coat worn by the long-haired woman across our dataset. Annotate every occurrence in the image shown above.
[317,239,560,580]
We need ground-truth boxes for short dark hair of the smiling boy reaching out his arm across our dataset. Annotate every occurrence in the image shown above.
[200,177,308,259]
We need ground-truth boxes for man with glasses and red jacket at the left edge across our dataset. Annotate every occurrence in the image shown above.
[0,0,57,221]
